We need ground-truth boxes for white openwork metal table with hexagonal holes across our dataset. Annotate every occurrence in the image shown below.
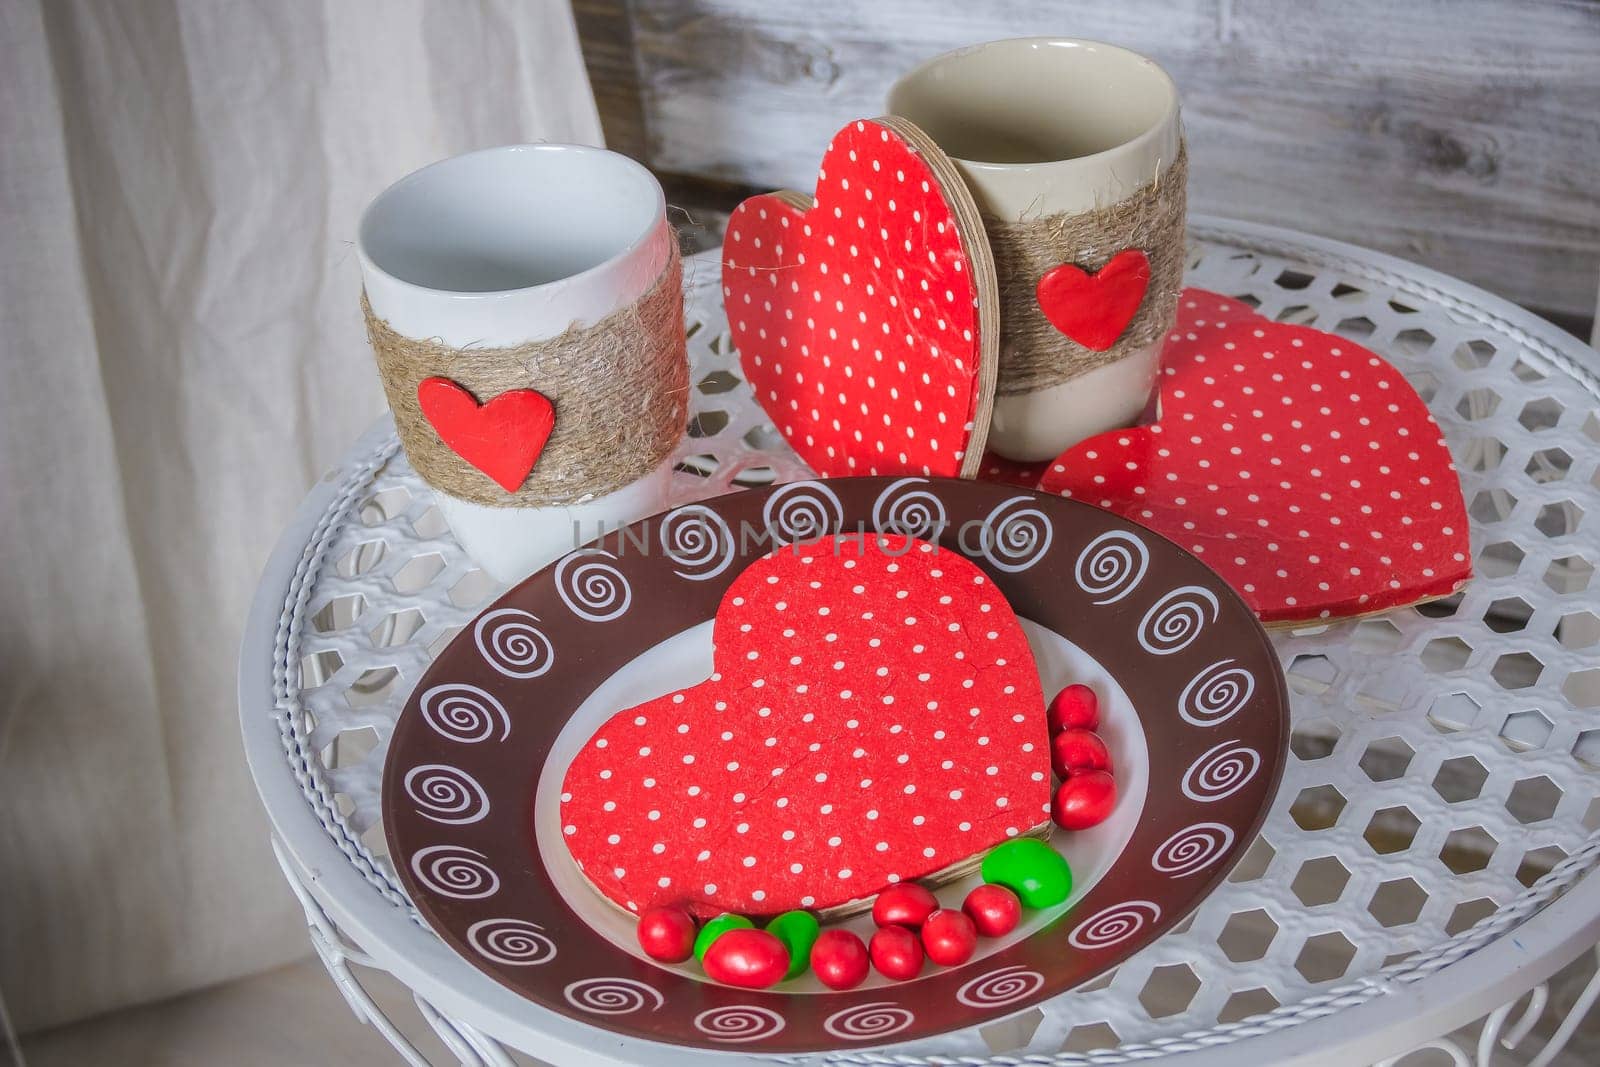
[240,219,1600,1067]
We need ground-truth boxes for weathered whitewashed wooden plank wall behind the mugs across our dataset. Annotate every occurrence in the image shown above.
[574,0,1600,325]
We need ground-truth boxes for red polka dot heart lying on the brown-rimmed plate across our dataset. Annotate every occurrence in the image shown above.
[562,534,1050,915]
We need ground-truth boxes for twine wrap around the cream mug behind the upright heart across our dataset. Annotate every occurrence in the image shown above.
[984,146,1189,397]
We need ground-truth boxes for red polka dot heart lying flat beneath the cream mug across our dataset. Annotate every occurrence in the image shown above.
[1040,290,1472,622]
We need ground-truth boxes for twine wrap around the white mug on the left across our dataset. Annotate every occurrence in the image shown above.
[362,242,688,507]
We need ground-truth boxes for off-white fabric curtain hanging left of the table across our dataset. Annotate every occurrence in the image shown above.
[0,0,600,1030]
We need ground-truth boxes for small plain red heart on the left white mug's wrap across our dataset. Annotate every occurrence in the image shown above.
[416,378,555,493]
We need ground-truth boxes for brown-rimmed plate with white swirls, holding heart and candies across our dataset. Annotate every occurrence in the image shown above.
[382,478,1288,1053]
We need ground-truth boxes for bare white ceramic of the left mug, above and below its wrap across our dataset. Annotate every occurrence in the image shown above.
[357,144,677,582]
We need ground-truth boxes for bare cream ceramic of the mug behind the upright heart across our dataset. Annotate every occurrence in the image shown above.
[888,37,1181,462]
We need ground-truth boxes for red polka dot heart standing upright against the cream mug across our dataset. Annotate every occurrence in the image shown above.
[722,118,1000,477]
